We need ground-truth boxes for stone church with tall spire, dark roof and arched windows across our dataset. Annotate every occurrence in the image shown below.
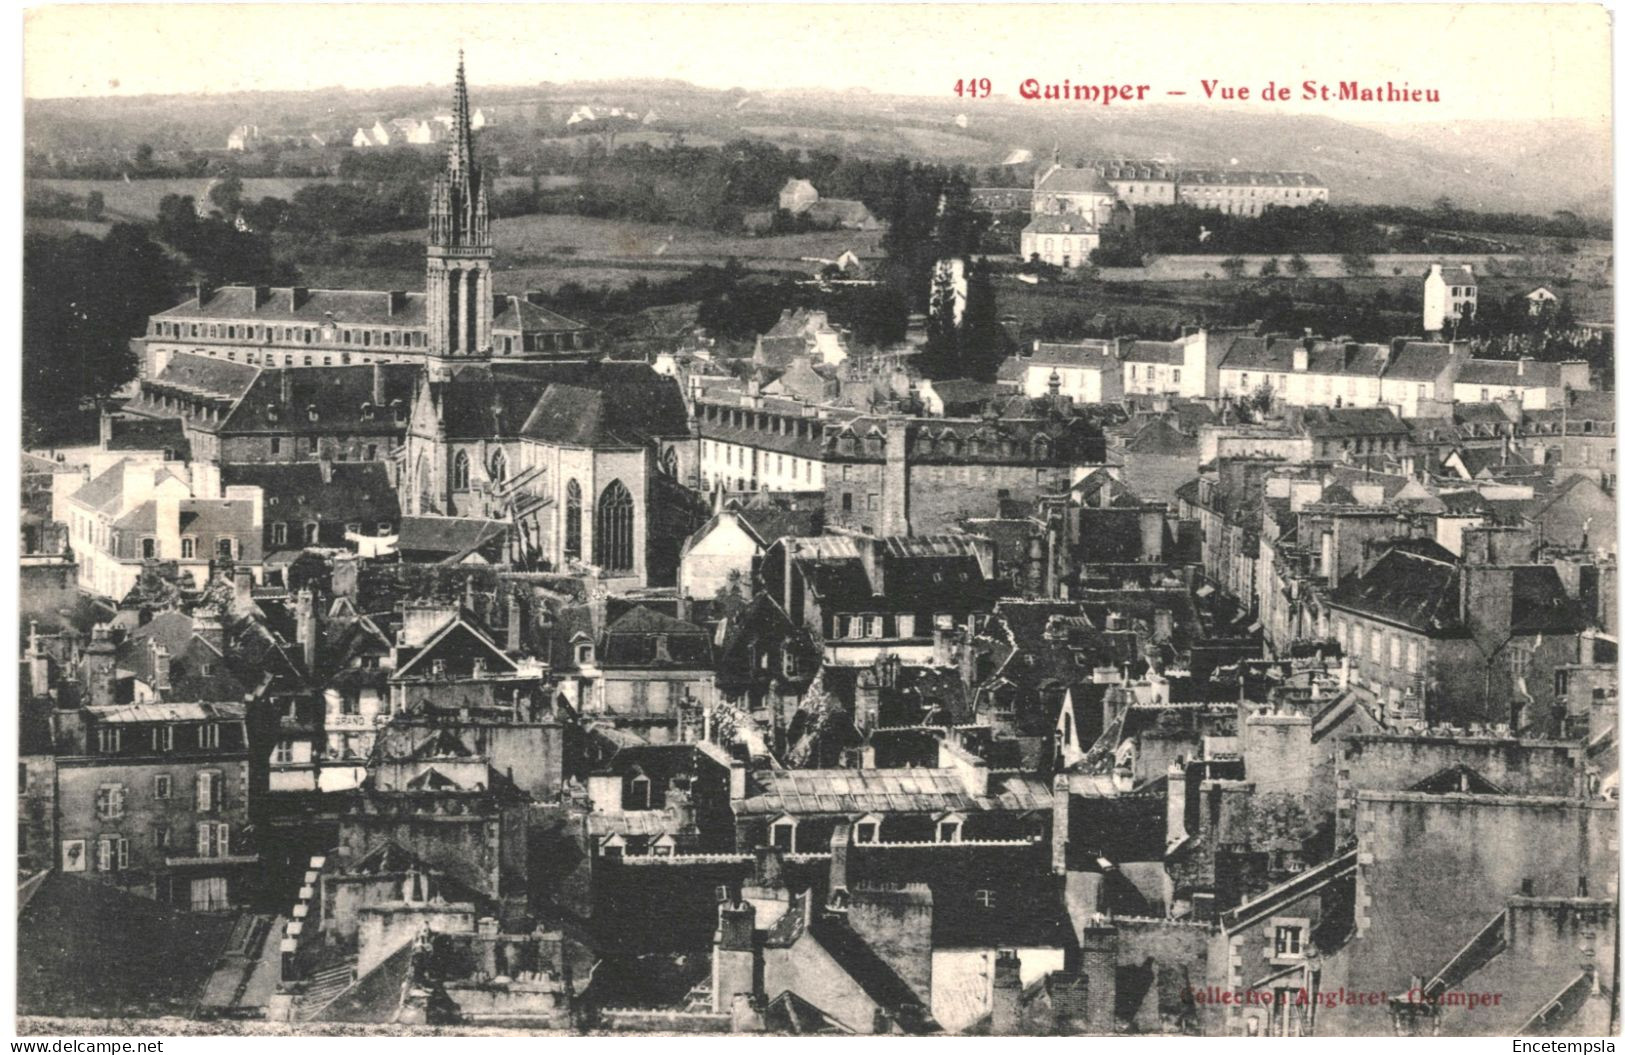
[398,57,705,588]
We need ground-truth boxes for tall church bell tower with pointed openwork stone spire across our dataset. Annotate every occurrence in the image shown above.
[427,52,492,380]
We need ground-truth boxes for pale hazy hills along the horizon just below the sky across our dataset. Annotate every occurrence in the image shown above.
[24,78,1612,218]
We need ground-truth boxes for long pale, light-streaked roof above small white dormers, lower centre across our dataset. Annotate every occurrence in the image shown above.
[733,769,1053,816]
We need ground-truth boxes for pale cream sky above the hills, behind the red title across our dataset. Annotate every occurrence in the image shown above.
[24,3,1612,122]
